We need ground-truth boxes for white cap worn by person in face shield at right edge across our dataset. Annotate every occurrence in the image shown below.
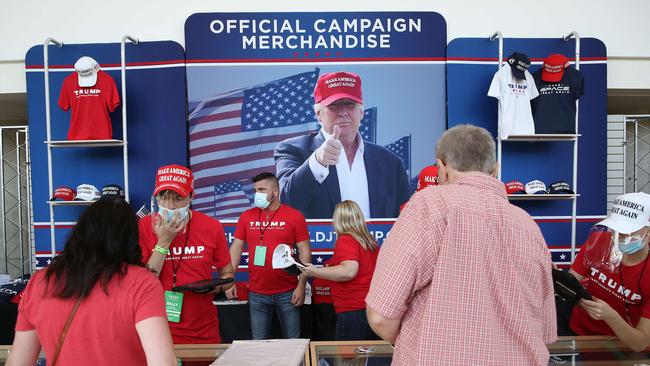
[598,192,650,234]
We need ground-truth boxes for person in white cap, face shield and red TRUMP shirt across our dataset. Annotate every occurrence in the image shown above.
[569,192,650,351]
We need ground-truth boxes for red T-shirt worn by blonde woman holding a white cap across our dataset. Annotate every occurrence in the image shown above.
[329,235,379,313]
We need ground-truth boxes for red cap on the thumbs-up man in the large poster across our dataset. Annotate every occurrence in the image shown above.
[314,71,363,107]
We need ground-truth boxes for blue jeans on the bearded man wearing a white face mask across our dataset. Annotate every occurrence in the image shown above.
[248,291,300,339]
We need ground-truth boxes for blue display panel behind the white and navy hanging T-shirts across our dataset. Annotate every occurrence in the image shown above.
[447,37,607,262]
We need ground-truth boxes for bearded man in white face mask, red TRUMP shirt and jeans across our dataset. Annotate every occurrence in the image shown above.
[226,173,311,339]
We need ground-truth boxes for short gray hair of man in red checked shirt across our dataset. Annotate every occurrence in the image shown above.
[436,124,497,174]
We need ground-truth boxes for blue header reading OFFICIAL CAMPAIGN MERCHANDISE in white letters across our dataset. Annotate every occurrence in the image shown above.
[185,12,447,63]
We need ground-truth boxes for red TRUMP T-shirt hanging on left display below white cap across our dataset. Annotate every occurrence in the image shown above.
[59,70,120,140]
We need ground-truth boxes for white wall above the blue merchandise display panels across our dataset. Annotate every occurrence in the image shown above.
[0,0,650,93]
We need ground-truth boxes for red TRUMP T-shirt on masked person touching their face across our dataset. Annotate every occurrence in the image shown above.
[140,210,230,344]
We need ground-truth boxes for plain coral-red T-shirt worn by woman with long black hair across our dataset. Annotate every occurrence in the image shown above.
[16,266,167,366]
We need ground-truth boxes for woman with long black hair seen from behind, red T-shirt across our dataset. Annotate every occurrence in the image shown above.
[7,199,176,366]
